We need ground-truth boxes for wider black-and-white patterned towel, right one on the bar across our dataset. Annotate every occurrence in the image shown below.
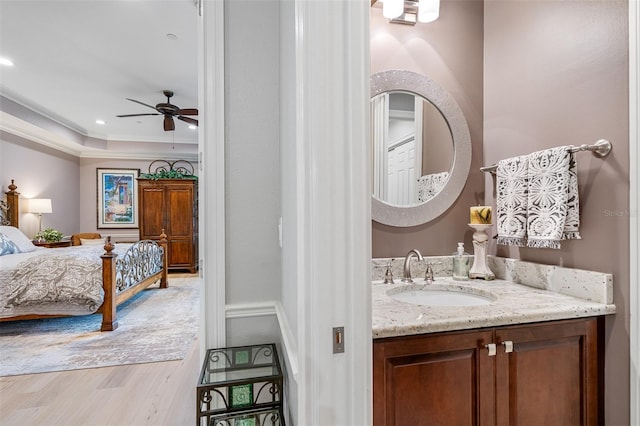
[527,146,580,249]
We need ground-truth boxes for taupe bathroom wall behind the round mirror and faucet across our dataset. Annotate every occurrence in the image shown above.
[371,0,484,257]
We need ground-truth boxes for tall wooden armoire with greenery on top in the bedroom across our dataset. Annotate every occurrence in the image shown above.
[138,178,198,272]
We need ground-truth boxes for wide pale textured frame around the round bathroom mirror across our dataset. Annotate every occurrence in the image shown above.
[370,70,471,227]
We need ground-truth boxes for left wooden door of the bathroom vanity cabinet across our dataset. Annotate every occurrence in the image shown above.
[373,331,495,426]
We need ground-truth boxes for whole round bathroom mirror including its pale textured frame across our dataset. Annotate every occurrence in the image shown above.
[371,70,471,227]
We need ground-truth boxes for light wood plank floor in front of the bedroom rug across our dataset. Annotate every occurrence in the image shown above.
[0,332,200,426]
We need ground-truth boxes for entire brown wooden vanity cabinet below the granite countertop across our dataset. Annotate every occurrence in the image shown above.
[373,318,603,426]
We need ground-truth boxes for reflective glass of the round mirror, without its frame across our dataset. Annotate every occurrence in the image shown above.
[371,91,453,206]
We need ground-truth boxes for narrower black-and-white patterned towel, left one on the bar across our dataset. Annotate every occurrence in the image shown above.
[496,156,528,247]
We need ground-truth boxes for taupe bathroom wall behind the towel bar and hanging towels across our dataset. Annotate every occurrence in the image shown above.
[484,0,635,425]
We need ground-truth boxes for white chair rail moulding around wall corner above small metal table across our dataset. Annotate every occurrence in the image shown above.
[225,301,298,382]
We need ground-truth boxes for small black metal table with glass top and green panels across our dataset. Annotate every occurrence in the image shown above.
[196,343,284,426]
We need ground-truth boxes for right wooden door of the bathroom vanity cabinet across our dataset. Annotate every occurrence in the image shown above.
[496,318,603,426]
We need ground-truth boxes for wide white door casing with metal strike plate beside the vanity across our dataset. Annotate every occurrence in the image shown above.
[295,0,372,426]
